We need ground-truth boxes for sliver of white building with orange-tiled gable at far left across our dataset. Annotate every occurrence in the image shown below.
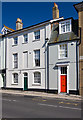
[0,25,14,88]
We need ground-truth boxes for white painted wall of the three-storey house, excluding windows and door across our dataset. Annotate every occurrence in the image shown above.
[6,23,51,89]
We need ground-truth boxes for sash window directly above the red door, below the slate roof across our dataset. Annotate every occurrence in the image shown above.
[59,44,68,59]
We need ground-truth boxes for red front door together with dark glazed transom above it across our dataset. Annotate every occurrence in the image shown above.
[60,67,67,93]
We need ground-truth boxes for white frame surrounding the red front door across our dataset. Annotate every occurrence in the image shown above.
[58,65,69,94]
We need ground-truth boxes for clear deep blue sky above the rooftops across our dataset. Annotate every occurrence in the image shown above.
[2,2,78,30]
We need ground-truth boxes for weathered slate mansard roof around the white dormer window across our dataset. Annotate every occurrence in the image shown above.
[49,19,78,43]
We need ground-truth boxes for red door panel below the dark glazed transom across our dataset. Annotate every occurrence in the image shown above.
[60,75,67,92]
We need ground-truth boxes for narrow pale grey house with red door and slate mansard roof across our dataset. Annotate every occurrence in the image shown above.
[48,18,79,94]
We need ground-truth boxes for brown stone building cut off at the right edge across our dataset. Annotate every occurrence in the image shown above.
[74,2,83,96]
